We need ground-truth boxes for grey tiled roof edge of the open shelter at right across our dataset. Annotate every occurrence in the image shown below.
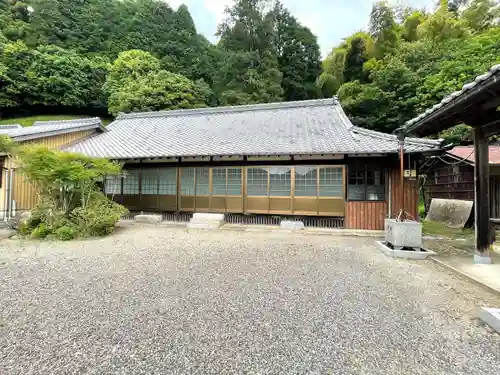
[402,64,500,131]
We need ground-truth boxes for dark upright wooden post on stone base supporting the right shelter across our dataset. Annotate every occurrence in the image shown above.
[473,126,491,263]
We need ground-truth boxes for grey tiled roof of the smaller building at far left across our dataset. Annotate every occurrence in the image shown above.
[0,117,106,141]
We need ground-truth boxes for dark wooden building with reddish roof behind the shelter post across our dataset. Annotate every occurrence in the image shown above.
[421,145,500,219]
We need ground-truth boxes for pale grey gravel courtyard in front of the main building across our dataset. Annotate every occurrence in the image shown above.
[0,227,500,375]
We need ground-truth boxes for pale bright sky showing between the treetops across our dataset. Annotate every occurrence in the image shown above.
[165,0,436,56]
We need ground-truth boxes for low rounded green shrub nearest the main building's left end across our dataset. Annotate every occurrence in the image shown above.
[71,193,128,236]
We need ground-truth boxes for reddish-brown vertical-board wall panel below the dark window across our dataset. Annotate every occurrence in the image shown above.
[344,202,388,230]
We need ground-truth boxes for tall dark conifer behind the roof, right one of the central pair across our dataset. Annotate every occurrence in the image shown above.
[268,1,322,100]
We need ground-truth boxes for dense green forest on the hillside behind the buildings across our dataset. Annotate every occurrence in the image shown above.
[0,0,500,142]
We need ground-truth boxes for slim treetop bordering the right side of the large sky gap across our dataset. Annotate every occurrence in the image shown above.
[370,0,399,59]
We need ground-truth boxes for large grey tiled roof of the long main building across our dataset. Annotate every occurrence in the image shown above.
[68,98,440,159]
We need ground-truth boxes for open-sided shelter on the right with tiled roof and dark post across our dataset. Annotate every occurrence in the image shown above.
[397,64,500,264]
